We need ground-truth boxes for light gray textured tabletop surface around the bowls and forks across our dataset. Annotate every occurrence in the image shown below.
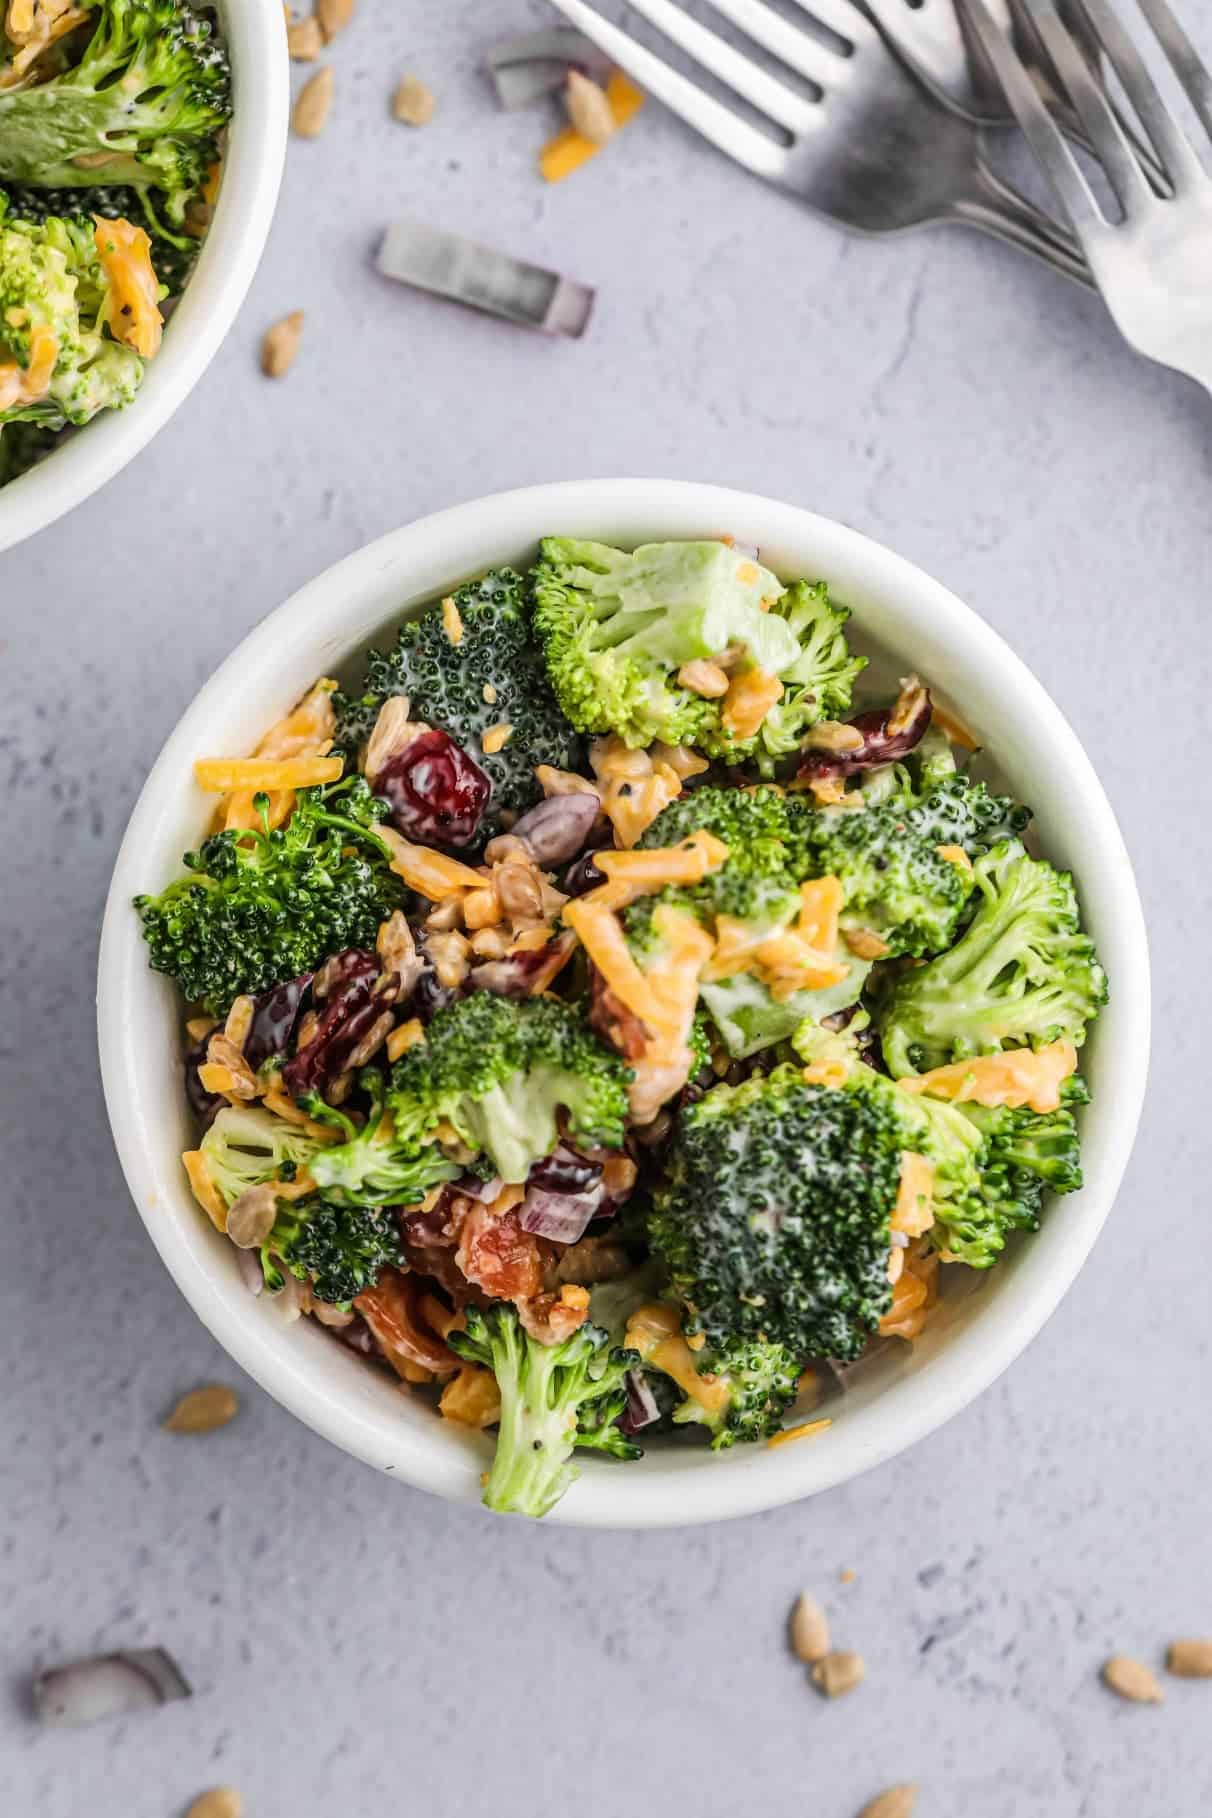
[0,0,1212,1818]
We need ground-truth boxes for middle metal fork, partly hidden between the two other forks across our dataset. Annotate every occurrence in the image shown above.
[863,0,1165,189]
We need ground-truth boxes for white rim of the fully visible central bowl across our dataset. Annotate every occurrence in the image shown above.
[98,478,1150,1527]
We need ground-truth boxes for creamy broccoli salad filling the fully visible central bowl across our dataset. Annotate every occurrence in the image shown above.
[136,536,1107,1516]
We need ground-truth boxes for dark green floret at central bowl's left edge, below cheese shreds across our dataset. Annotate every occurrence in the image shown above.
[134,776,405,1016]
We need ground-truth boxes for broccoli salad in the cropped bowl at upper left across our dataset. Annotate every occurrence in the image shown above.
[0,0,231,485]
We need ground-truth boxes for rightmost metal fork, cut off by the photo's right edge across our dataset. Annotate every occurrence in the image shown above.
[963,0,1212,391]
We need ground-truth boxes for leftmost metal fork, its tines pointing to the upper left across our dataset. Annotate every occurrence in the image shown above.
[554,0,1090,284]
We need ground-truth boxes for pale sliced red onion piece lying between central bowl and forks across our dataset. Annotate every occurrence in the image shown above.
[378,222,594,338]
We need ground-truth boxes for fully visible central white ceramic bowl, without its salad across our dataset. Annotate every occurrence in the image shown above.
[98,480,1148,1527]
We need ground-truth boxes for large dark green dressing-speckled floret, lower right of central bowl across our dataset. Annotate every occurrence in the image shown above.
[649,1065,903,1358]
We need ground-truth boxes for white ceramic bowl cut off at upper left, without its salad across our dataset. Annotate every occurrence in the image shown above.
[0,0,291,551]
